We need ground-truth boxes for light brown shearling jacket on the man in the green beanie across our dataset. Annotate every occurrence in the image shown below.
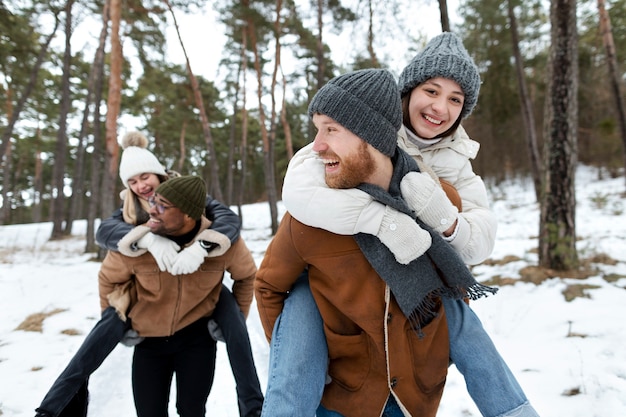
[98,217,257,337]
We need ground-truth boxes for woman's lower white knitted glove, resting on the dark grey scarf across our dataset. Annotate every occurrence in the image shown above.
[376,206,432,265]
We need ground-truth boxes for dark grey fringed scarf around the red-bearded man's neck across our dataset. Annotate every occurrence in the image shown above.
[354,148,497,335]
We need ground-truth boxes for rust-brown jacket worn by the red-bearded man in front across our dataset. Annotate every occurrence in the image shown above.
[255,213,449,417]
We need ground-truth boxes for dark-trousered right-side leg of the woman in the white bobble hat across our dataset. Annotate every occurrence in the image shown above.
[212,285,263,417]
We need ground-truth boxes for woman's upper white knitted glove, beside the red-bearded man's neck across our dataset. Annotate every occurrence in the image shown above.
[400,172,459,233]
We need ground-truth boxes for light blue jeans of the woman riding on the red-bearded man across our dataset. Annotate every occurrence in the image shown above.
[262,274,539,417]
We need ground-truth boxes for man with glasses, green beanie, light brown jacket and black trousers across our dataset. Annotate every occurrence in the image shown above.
[98,176,257,417]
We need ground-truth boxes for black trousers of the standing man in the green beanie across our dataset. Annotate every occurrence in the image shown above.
[133,317,215,417]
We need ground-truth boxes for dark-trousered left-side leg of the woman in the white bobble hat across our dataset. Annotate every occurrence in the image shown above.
[37,307,130,417]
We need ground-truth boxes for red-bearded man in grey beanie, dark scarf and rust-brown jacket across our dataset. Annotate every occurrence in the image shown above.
[255,69,491,417]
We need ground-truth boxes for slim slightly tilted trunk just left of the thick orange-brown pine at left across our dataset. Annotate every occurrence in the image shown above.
[85,0,111,254]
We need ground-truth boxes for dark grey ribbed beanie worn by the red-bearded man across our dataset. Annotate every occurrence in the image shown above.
[309,69,402,156]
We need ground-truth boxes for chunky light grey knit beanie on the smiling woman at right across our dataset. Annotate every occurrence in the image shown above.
[398,32,480,119]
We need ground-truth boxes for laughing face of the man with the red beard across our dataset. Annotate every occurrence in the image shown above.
[313,114,376,188]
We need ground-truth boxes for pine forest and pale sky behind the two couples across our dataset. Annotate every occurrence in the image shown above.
[0,0,626,266]
